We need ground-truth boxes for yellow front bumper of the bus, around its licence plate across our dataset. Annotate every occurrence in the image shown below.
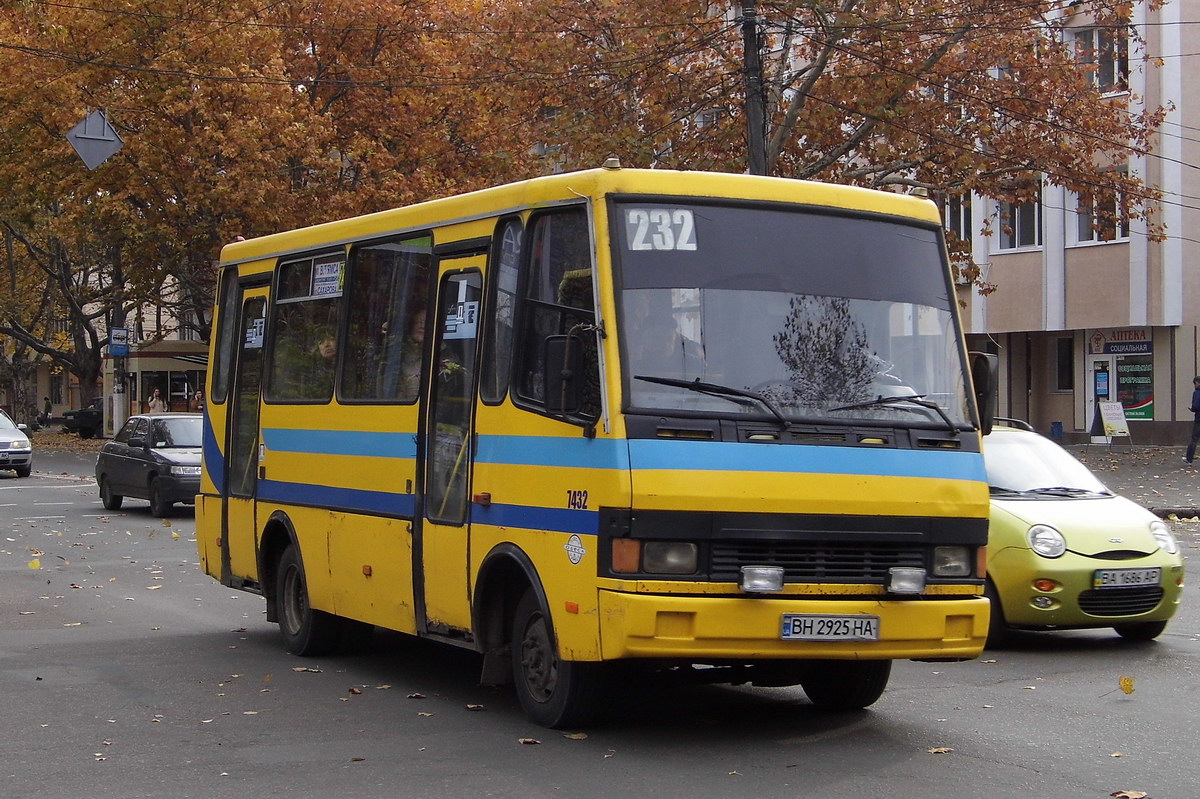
[600,590,989,661]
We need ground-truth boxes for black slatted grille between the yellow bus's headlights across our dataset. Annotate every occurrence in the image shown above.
[709,541,925,584]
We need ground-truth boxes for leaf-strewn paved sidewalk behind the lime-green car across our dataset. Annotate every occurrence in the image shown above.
[1066,444,1200,519]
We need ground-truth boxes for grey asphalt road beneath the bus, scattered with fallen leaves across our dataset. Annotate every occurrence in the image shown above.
[0,452,1200,799]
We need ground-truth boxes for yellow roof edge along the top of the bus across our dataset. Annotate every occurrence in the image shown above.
[220,168,941,266]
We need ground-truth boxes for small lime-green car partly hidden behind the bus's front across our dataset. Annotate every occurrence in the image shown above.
[984,425,1183,644]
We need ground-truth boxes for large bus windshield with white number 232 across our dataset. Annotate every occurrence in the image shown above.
[613,198,971,428]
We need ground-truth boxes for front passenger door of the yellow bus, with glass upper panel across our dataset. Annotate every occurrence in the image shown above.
[418,263,484,635]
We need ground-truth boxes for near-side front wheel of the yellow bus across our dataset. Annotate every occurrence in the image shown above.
[512,590,605,727]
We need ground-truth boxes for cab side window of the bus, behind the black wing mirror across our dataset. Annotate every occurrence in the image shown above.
[517,209,600,419]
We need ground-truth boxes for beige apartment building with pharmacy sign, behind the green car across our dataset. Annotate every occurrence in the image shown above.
[947,0,1200,444]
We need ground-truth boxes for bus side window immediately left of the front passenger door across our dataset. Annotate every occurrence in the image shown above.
[338,235,433,402]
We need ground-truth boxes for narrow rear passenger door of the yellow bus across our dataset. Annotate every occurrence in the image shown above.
[221,288,268,587]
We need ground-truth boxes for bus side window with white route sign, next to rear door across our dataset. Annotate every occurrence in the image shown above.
[266,257,346,402]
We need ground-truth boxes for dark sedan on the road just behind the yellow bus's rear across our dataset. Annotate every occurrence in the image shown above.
[96,414,203,516]
